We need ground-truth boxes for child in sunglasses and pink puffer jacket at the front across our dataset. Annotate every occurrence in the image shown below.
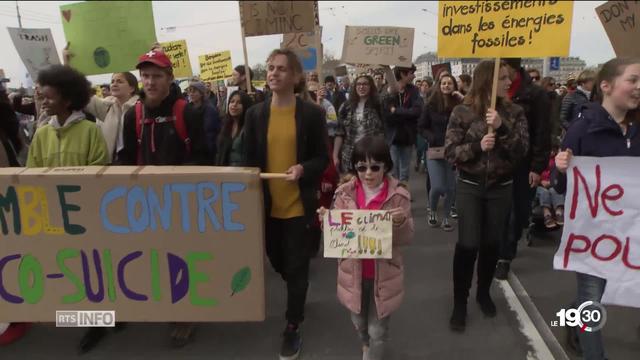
[318,136,413,360]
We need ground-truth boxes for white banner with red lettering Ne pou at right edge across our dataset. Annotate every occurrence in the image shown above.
[553,157,640,307]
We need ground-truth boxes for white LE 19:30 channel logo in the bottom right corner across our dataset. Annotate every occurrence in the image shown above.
[551,301,607,332]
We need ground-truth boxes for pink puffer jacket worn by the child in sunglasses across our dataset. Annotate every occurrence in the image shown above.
[333,178,413,319]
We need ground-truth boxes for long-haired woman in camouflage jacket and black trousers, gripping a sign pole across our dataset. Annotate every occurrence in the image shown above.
[445,61,529,332]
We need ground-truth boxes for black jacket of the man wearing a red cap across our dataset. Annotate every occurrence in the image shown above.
[117,85,208,165]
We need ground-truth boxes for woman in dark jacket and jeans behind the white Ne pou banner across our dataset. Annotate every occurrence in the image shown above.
[555,58,640,360]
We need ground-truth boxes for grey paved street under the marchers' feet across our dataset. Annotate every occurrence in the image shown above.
[0,167,640,360]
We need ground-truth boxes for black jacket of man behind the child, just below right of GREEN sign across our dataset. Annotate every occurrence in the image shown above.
[383,84,424,146]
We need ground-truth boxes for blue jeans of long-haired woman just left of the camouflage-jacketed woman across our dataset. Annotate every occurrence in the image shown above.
[427,159,456,217]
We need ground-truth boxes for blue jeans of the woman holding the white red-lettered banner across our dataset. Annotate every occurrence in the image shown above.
[574,273,607,360]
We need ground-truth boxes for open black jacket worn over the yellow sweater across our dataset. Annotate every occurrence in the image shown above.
[244,97,329,222]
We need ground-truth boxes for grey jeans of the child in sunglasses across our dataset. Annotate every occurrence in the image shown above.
[351,279,389,360]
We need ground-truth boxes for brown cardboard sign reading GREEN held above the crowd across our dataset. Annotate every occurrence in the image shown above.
[342,26,414,67]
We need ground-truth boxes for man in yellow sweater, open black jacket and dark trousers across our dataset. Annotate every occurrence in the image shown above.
[245,49,329,360]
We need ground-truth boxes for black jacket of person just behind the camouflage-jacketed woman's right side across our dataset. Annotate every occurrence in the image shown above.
[511,69,551,174]
